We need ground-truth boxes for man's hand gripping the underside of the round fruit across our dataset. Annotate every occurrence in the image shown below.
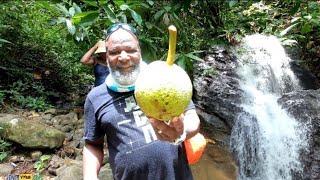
[149,114,184,142]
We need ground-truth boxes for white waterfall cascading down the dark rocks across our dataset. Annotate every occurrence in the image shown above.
[231,35,307,180]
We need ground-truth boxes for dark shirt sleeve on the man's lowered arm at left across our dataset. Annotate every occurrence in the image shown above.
[83,97,104,142]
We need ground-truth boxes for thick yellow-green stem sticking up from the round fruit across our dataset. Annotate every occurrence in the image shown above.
[167,25,177,65]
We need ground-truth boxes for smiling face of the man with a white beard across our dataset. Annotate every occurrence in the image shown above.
[106,28,141,85]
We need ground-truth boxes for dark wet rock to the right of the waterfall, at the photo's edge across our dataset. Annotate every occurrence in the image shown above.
[278,89,320,179]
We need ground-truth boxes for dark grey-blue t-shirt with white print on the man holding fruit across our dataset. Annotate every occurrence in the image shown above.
[84,84,194,180]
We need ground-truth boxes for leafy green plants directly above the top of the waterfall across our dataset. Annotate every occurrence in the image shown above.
[219,1,282,44]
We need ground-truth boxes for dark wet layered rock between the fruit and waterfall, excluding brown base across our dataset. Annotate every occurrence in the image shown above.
[193,47,242,141]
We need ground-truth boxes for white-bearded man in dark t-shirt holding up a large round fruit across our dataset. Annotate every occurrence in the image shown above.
[83,23,200,180]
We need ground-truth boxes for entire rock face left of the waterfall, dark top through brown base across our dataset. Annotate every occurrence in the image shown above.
[192,47,242,179]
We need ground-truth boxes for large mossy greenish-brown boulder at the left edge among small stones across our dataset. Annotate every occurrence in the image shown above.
[0,114,65,149]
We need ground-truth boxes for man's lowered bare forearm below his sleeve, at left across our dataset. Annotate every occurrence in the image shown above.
[83,140,103,180]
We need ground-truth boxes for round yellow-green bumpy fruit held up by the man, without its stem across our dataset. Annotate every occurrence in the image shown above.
[135,61,192,121]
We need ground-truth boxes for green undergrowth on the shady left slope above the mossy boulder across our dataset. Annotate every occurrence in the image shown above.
[0,1,92,110]
